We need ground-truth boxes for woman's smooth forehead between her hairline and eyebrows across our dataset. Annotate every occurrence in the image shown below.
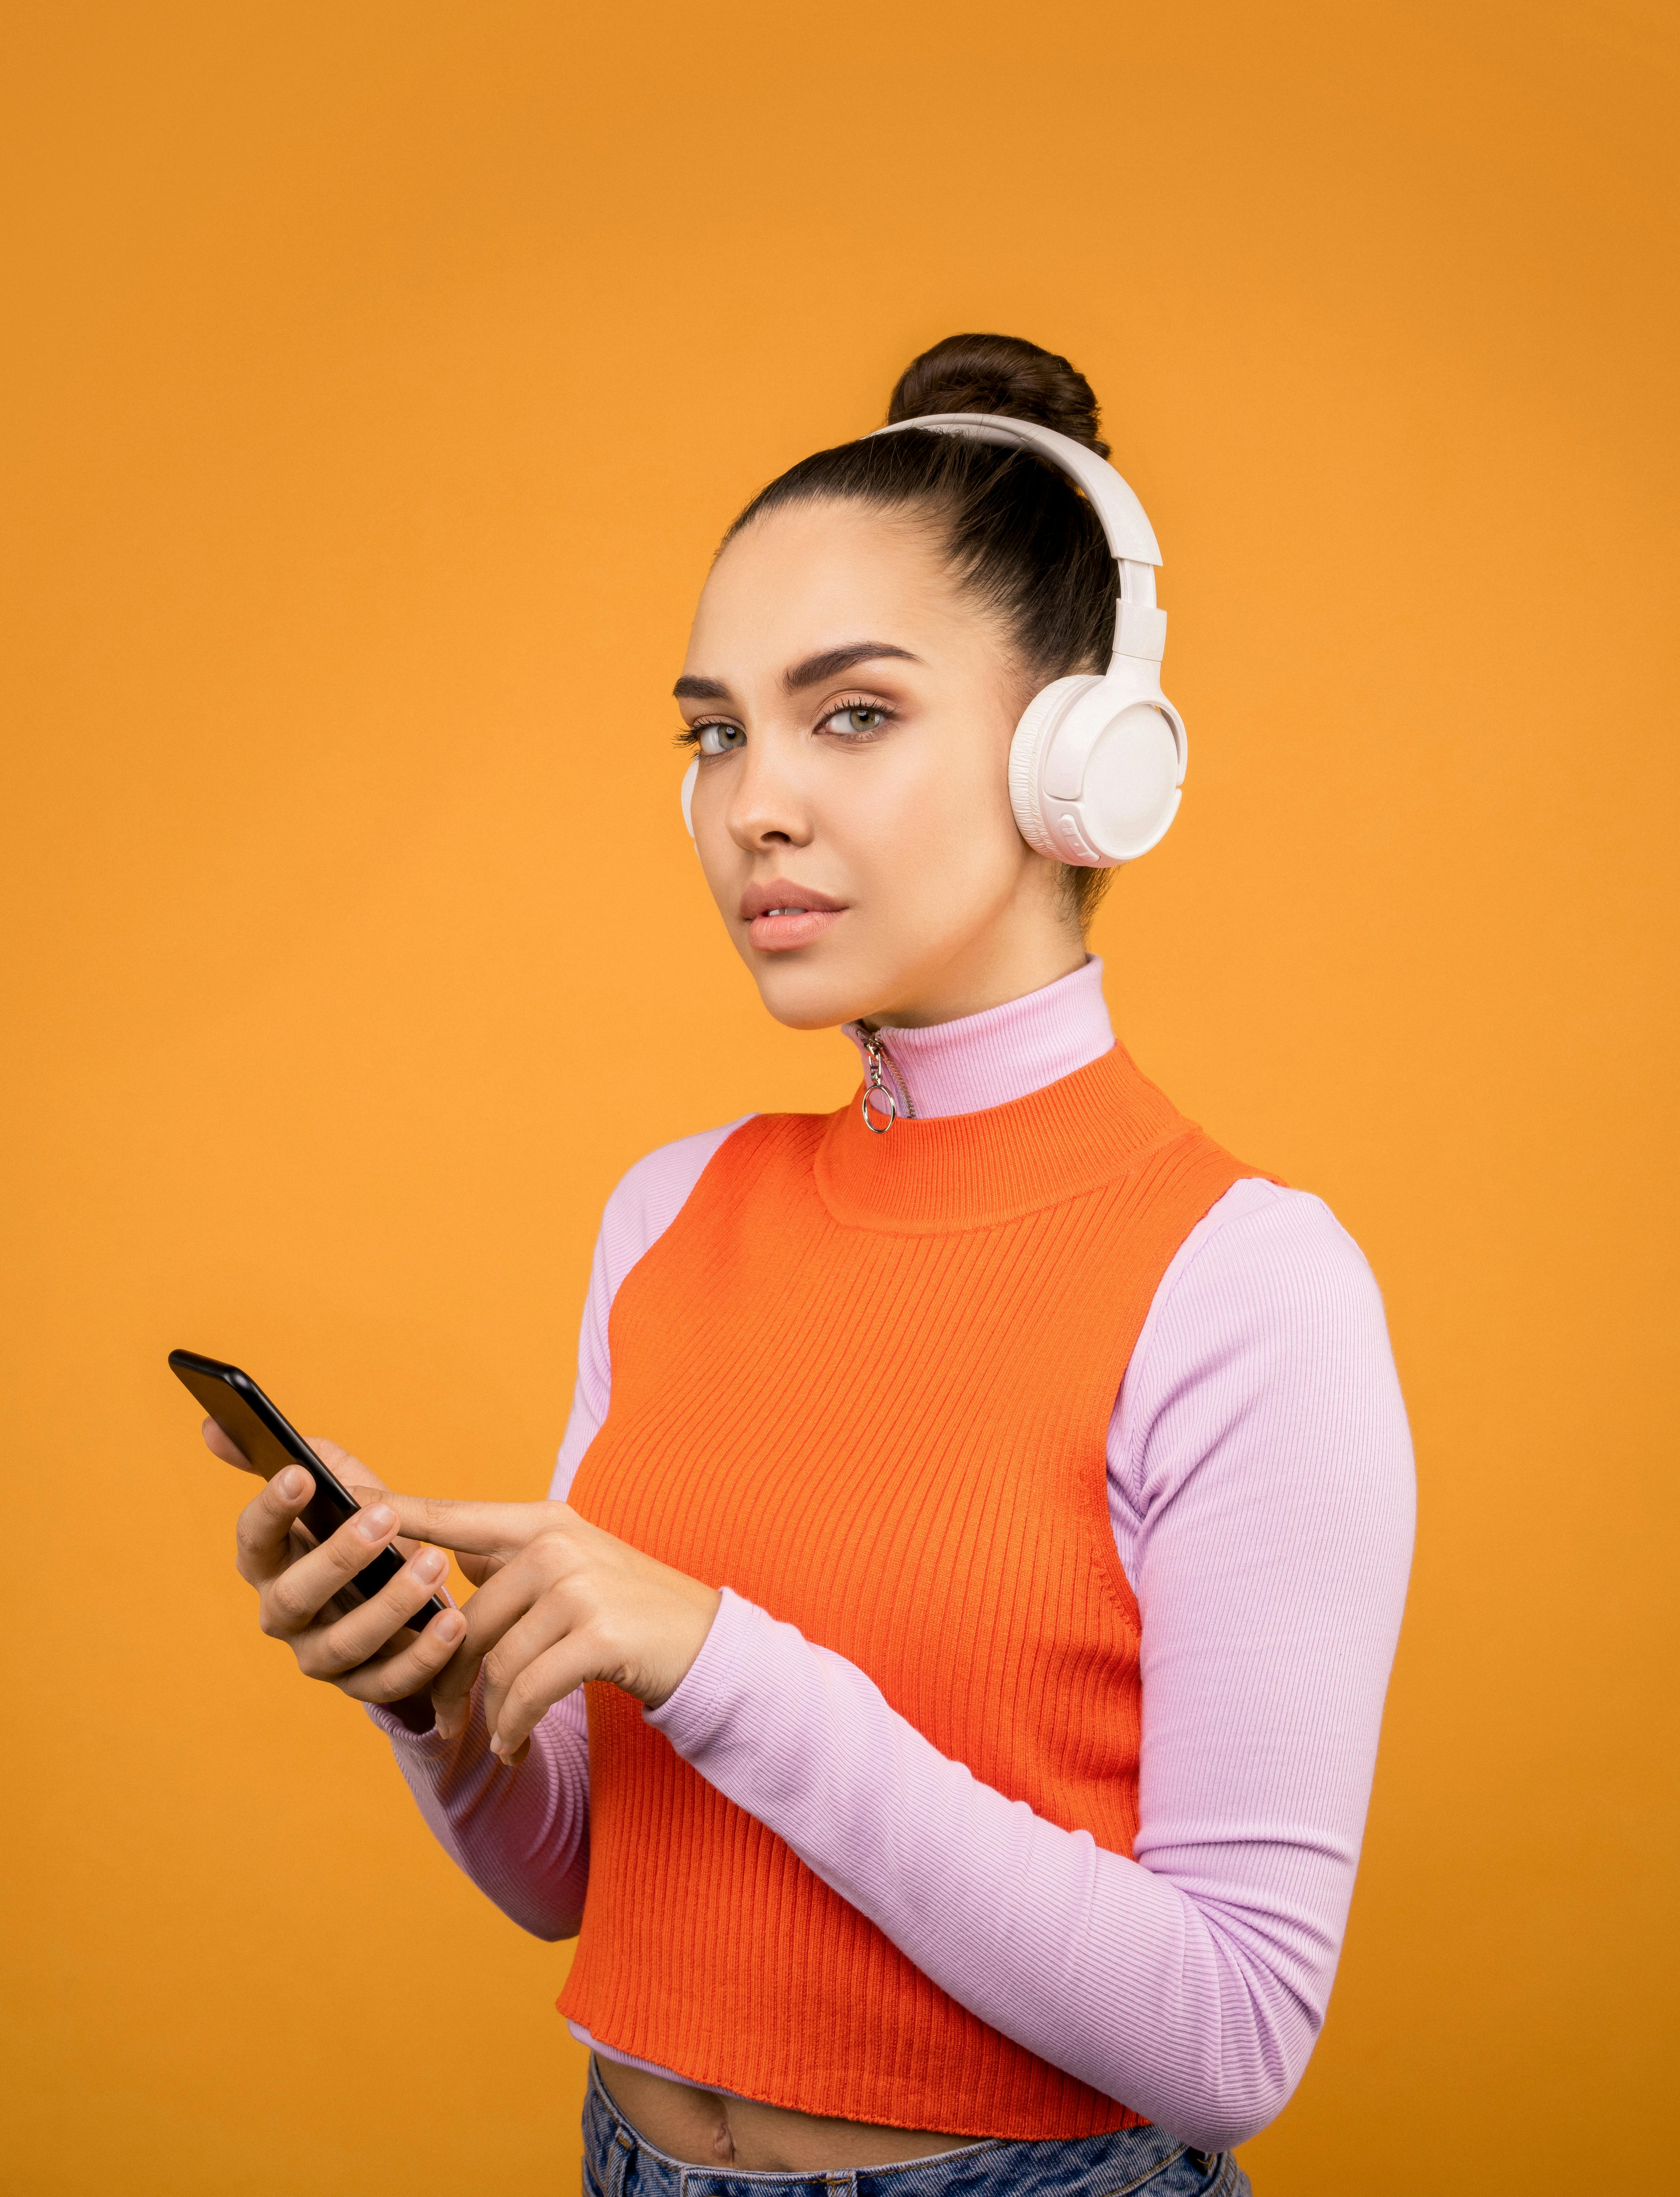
[683,503,982,677]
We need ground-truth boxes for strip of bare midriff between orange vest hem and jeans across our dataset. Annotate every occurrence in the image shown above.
[595,2056,973,2175]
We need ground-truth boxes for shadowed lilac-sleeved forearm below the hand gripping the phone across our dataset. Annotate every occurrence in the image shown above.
[369,1685,589,1938]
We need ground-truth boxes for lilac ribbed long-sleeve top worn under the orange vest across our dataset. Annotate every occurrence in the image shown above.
[373,960,1414,2149]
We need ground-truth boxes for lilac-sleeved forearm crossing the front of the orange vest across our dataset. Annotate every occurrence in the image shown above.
[650,1595,1326,2149]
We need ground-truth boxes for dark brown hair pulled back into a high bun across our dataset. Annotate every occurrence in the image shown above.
[725,336,1116,925]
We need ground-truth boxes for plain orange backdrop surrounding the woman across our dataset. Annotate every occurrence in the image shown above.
[0,0,1680,2197]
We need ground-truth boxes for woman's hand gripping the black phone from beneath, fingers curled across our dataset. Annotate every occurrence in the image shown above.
[204,1419,465,1731]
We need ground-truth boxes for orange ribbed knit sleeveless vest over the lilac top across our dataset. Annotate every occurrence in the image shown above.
[560,1046,1252,2138]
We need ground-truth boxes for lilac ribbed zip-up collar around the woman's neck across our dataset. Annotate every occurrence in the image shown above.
[845,956,1113,1120]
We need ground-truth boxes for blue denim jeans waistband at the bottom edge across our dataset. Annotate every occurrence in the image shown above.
[584,2061,1252,2197]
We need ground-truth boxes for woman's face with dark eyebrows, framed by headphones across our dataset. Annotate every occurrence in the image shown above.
[677,503,1085,1030]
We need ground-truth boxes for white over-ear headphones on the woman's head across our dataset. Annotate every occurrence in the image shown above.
[683,413,1190,870]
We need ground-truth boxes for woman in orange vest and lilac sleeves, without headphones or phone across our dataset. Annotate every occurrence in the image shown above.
[211,336,1412,2197]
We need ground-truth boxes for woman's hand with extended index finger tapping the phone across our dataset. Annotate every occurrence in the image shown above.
[384,1494,722,1762]
